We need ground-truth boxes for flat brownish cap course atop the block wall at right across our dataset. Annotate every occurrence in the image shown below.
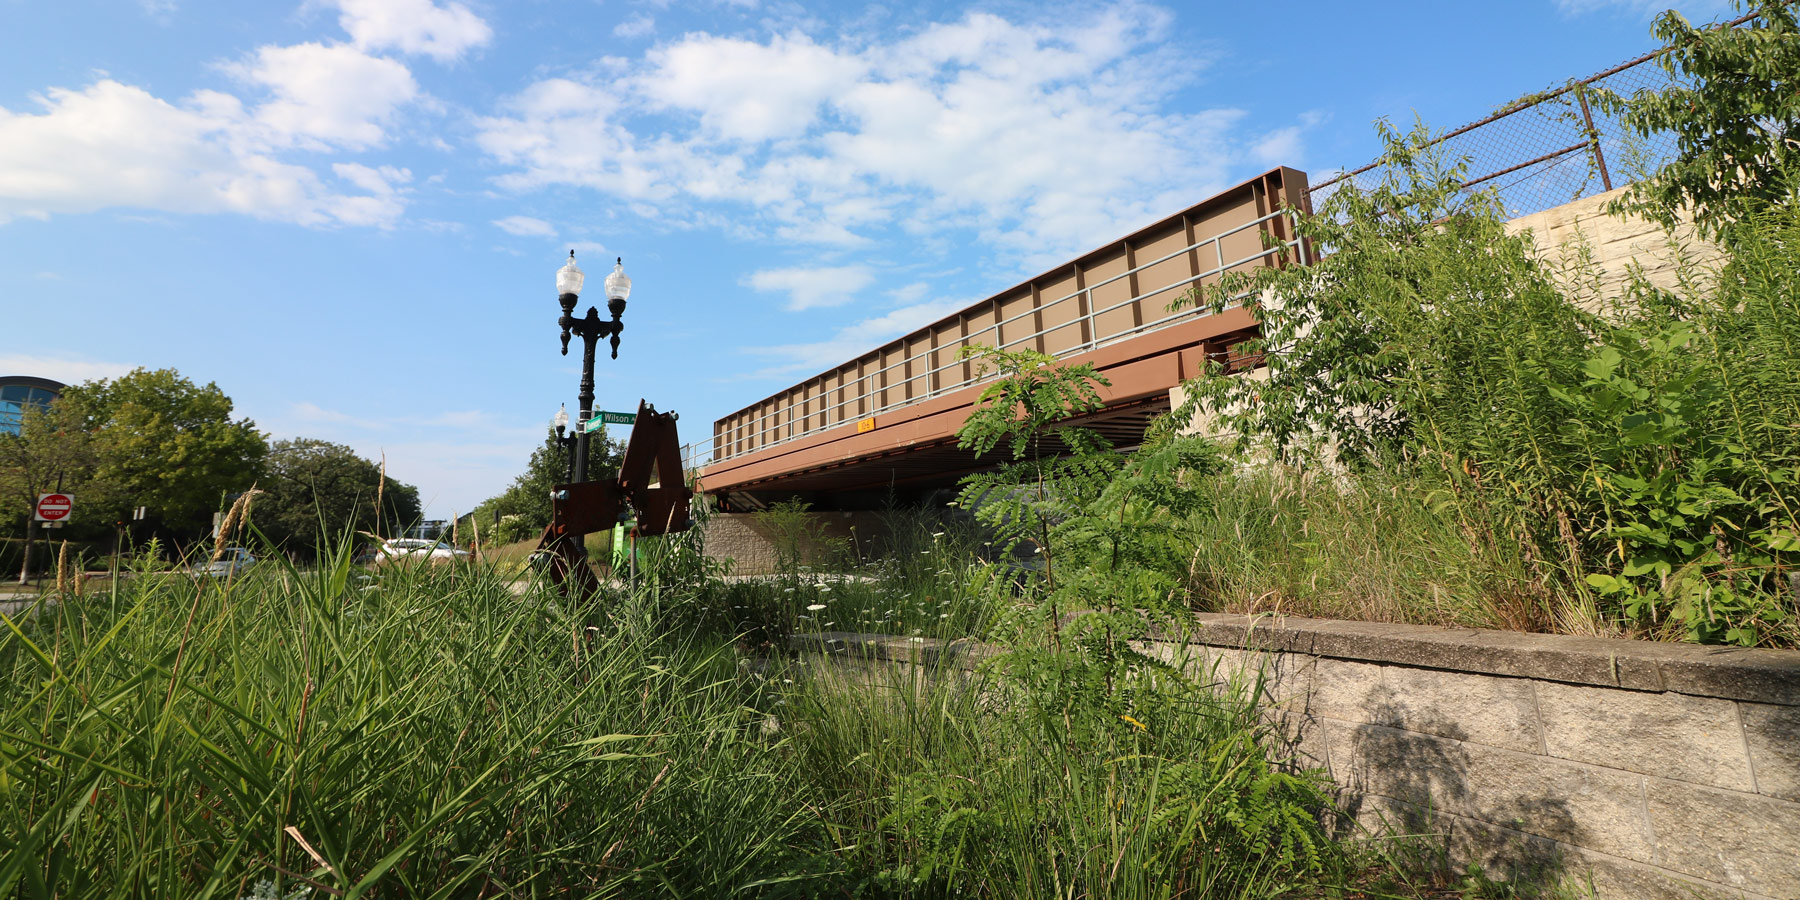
[1166,612,1800,706]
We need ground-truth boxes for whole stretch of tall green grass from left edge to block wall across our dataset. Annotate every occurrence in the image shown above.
[0,532,1447,898]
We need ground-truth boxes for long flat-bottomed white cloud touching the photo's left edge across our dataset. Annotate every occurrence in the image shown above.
[0,79,401,225]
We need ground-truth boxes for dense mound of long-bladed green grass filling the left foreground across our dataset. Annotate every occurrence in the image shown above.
[0,553,817,896]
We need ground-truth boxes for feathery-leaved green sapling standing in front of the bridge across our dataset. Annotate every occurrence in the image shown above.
[928,347,1325,896]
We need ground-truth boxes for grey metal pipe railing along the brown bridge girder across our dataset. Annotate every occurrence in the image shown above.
[705,209,1298,468]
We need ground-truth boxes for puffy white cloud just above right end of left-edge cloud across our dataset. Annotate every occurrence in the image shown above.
[225,43,419,149]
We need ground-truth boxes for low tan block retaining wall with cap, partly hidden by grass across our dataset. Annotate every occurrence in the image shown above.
[799,614,1800,900]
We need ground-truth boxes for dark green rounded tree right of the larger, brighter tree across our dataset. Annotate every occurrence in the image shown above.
[254,437,421,556]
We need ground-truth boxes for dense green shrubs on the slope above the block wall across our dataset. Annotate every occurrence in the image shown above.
[1188,119,1800,644]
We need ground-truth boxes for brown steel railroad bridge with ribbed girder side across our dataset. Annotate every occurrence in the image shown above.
[700,167,1307,511]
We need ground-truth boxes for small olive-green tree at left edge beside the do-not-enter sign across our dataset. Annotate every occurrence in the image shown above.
[0,400,104,583]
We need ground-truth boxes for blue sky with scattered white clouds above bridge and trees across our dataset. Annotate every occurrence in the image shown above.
[0,0,1732,518]
